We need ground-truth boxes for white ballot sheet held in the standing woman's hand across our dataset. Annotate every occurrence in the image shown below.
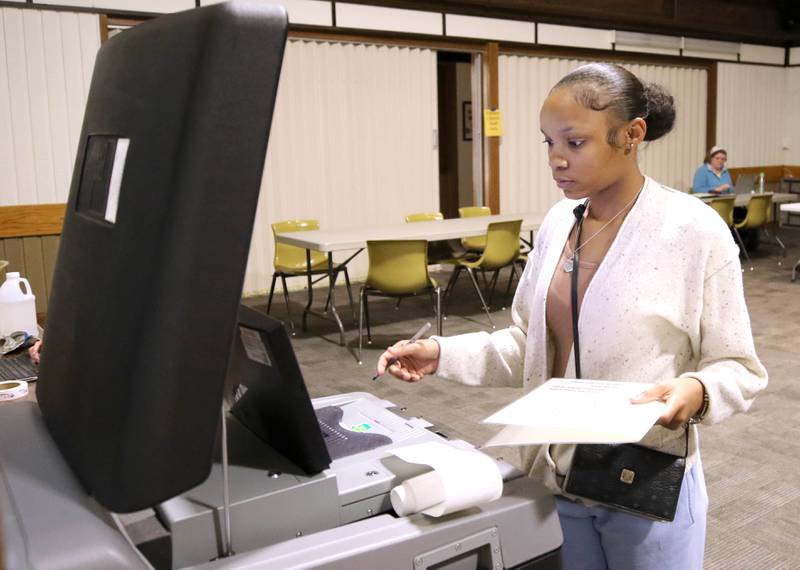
[483,378,666,447]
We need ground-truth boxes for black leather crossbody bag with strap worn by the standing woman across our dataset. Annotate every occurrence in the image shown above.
[564,203,689,522]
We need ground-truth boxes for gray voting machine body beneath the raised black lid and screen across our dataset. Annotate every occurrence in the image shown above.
[0,393,562,570]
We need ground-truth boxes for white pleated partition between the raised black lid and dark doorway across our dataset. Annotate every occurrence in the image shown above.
[244,41,439,294]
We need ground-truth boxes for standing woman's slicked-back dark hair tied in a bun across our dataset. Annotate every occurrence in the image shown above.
[553,63,675,146]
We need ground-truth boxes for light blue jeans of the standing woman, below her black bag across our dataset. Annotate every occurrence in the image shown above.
[556,457,708,570]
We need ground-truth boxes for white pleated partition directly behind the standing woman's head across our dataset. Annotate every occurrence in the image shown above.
[500,55,707,214]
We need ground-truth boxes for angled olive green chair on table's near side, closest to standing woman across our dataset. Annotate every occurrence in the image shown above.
[445,220,522,328]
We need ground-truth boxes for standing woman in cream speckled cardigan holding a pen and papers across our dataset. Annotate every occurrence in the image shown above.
[378,63,767,570]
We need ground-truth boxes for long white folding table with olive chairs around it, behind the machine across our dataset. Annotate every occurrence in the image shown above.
[275,214,544,346]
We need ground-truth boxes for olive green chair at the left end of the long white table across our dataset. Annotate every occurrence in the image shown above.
[267,220,355,324]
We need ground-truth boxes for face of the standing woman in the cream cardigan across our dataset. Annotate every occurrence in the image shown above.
[539,87,635,200]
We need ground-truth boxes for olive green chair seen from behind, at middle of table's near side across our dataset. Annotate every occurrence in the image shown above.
[358,239,442,364]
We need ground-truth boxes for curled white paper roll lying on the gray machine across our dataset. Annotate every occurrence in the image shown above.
[389,441,503,517]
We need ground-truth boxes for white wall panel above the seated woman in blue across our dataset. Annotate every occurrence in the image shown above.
[716,63,784,167]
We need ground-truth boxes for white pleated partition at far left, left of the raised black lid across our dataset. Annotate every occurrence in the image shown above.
[0,8,100,206]
